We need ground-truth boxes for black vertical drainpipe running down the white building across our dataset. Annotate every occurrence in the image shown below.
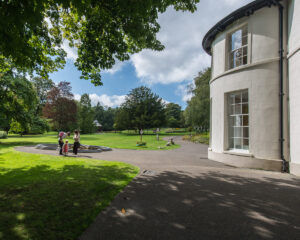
[276,1,289,172]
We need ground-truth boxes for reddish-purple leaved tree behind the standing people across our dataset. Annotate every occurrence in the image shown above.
[43,81,77,131]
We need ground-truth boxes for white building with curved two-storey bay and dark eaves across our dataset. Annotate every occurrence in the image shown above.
[203,0,300,175]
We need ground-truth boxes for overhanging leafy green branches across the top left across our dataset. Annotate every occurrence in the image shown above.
[0,0,199,85]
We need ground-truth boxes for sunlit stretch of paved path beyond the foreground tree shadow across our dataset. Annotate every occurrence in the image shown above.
[15,136,228,171]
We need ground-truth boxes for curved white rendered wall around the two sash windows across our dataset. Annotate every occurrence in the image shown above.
[210,6,280,167]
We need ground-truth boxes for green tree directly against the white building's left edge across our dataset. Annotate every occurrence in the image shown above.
[184,68,211,131]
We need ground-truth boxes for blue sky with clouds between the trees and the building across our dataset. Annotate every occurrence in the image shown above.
[50,0,252,109]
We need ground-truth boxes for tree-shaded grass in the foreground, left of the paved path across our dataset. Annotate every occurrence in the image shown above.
[0,162,135,240]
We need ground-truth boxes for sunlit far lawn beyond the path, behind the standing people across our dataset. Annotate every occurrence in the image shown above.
[1,132,180,150]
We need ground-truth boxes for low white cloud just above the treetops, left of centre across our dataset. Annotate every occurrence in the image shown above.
[74,93,125,107]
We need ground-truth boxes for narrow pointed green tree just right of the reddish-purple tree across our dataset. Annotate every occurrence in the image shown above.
[79,93,95,133]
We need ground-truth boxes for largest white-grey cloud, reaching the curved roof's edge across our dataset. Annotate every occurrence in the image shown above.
[131,0,251,85]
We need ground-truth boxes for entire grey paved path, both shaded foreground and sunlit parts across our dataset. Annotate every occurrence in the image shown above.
[17,138,300,240]
